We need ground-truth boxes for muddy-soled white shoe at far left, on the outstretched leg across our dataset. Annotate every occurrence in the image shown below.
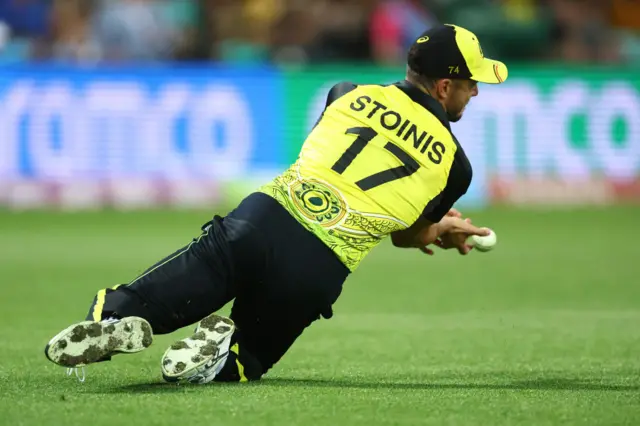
[44,317,153,368]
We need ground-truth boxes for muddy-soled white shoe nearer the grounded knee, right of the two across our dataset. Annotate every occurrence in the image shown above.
[161,314,236,384]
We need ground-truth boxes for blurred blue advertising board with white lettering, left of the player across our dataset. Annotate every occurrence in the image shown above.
[0,66,284,207]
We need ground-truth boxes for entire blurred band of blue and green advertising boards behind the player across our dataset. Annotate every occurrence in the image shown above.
[0,65,640,208]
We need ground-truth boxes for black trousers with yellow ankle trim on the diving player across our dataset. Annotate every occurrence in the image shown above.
[87,193,349,381]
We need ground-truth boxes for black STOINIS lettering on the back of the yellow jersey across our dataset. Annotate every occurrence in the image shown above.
[350,95,446,164]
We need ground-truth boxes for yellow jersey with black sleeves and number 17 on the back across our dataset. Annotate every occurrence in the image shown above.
[260,81,472,271]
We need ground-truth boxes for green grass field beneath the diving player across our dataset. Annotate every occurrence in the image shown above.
[0,207,640,426]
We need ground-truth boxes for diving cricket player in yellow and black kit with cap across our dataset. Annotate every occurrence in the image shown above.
[45,25,508,383]
